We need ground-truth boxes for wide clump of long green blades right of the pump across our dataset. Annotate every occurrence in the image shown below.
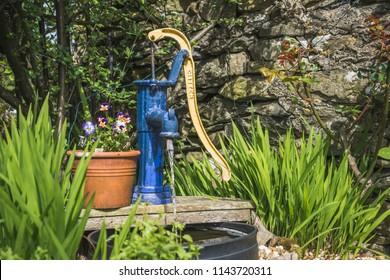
[175,117,390,258]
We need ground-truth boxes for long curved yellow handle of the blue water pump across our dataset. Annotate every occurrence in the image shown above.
[148,28,231,181]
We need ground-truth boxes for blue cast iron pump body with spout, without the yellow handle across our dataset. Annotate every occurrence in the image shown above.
[132,50,188,204]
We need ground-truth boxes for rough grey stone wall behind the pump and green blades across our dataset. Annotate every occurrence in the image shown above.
[130,0,390,253]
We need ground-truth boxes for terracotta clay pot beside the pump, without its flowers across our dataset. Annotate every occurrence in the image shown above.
[68,150,140,209]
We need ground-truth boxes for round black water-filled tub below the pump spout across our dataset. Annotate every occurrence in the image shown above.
[88,222,258,260]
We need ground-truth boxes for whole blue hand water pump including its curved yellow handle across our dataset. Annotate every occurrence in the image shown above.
[132,28,231,204]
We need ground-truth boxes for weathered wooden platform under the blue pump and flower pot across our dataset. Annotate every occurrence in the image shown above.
[82,196,254,230]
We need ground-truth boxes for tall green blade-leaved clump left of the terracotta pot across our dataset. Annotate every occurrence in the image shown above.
[0,97,92,259]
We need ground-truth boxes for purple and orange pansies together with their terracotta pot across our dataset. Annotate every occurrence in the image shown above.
[68,102,140,209]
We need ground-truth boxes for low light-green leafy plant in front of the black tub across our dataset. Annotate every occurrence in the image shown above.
[93,199,200,260]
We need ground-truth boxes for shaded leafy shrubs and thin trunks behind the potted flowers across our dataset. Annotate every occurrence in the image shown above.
[0,0,161,147]
